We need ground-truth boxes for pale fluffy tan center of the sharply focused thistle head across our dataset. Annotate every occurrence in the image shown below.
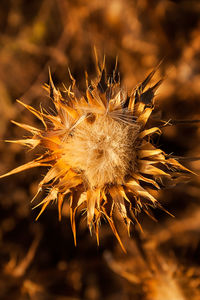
[62,116,138,188]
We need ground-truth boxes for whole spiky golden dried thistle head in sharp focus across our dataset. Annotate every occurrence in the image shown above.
[1,57,191,248]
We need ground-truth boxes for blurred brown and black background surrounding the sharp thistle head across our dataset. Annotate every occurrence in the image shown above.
[0,0,200,300]
